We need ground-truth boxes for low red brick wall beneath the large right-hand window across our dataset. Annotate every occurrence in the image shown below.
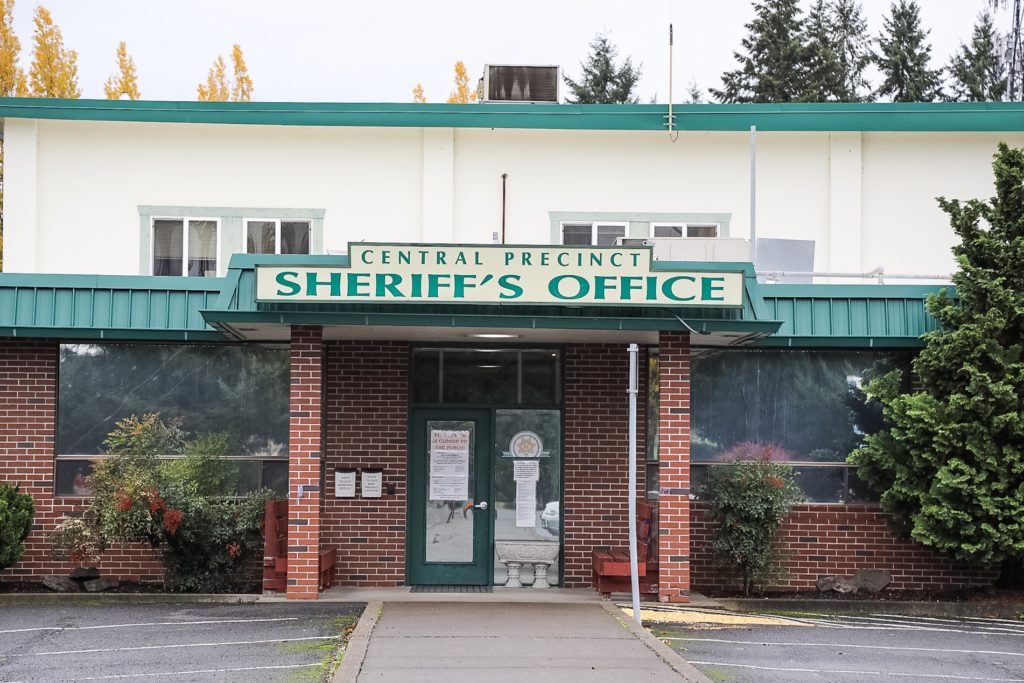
[690,503,998,590]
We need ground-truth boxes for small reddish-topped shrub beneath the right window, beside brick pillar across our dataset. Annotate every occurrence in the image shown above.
[708,447,802,595]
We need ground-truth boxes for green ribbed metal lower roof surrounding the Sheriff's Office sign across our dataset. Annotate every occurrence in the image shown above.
[0,255,941,348]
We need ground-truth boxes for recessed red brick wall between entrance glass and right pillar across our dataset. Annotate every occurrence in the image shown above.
[561,344,647,588]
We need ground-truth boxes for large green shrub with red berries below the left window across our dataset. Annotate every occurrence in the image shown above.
[51,414,271,593]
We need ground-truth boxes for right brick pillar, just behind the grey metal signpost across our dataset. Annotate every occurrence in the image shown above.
[657,332,690,602]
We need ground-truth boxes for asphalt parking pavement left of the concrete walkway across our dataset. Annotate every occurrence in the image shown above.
[0,603,362,683]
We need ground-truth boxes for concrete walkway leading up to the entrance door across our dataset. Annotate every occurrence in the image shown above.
[335,602,709,683]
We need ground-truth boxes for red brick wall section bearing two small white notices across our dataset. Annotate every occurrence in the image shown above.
[321,341,409,586]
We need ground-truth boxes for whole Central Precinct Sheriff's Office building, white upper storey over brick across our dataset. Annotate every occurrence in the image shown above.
[0,89,1024,602]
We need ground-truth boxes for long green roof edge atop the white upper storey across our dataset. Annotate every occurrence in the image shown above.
[0,97,1024,132]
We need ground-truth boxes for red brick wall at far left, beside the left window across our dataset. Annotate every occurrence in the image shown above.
[0,339,163,582]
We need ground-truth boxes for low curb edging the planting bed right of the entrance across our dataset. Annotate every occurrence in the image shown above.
[716,598,1024,620]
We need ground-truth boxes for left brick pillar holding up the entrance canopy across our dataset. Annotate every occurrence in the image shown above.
[288,327,324,600]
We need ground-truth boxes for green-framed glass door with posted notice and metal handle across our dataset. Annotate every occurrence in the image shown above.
[408,409,494,586]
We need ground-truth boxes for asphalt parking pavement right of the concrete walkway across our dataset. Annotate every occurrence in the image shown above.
[650,615,1024,683]
